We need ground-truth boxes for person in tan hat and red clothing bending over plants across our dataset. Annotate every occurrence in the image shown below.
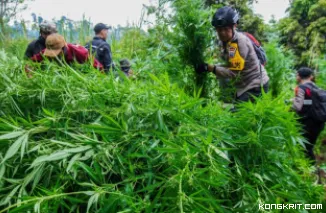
[31,33,103,70]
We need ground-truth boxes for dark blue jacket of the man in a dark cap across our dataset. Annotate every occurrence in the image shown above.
[85,36,112,72]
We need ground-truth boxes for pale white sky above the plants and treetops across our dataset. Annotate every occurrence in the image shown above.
[17,0,289,26]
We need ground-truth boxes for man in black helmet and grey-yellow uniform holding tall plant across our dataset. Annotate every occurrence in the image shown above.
[197,7,269,102]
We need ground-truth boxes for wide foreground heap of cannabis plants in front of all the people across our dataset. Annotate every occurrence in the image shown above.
[0,56,323,212]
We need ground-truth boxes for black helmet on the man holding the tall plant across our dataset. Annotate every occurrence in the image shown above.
[212,6,239,28]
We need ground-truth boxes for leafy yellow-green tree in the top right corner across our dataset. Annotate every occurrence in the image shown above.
[278,0,326,67]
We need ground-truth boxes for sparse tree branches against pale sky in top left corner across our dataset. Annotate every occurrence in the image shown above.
[0,0,27,34]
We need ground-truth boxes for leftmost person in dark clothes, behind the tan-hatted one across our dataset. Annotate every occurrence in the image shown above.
[25,21,57,59]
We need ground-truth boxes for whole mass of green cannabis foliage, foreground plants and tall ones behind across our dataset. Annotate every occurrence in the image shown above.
[0,0,326,213]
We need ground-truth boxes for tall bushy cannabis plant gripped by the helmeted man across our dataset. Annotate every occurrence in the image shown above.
[172,0,212,97]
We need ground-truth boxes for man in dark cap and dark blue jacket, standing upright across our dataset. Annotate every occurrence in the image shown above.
[85,23,114,72]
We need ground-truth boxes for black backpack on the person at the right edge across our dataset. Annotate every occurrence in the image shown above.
[307,85,326,122]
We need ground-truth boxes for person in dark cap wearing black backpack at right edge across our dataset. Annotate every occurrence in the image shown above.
[292,67,325,162]
